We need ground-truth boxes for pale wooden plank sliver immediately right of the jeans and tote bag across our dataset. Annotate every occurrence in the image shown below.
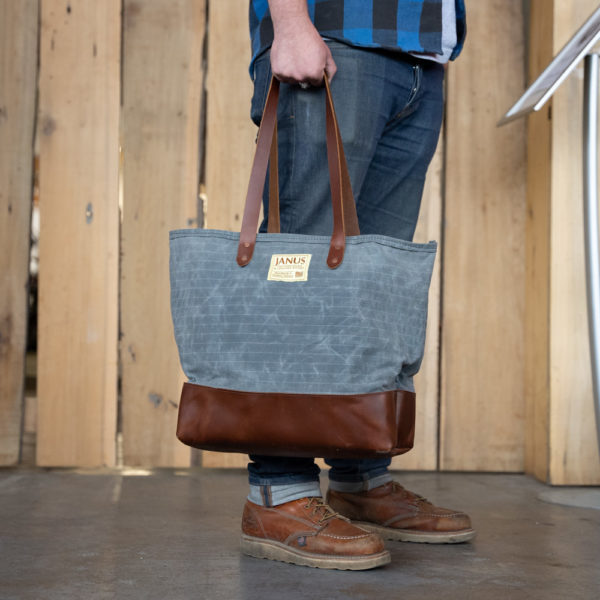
[392,139,444,471]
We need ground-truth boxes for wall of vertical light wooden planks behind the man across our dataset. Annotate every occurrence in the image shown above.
[0,0,600,484]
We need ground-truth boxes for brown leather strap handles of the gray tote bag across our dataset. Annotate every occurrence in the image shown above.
[237,75,360,269]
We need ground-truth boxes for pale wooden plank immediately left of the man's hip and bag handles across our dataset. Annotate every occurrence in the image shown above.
[202,0,256,467]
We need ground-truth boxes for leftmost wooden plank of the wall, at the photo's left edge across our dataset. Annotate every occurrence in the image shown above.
[0,0,38,465]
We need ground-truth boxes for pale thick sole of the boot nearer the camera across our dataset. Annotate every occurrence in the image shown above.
[241,535,391,571]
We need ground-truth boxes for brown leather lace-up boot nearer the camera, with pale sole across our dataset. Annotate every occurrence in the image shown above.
[242,498,390,571]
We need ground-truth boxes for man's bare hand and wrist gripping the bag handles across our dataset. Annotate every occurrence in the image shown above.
[269,0,337,86]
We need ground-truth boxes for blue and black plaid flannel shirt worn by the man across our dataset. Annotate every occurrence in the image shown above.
[249,0,467,73]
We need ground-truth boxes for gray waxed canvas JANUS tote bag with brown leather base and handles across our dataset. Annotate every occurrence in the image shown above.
[170,79,437,458]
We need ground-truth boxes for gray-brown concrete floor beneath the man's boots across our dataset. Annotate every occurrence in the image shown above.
[0,469,600,600]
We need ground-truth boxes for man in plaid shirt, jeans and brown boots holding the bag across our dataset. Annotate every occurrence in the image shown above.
[242,0,475,569]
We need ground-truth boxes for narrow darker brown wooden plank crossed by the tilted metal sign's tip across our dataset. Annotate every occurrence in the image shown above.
[525,0,553,481]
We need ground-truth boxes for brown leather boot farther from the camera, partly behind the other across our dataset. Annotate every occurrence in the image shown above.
[327,481,475,544]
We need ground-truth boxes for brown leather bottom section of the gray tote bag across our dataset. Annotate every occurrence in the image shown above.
[177,383,415,458]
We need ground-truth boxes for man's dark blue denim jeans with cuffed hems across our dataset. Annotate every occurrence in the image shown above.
[248,41,444,504]
